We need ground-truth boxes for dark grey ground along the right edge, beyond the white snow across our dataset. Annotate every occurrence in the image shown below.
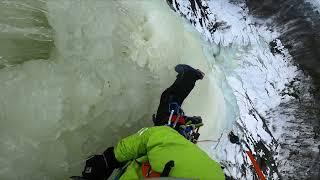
[247,0,320,179]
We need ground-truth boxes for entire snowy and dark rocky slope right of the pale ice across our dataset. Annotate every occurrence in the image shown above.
[167,0,320,179]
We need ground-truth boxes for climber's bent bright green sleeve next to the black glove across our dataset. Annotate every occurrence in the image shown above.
[114,128,150,162]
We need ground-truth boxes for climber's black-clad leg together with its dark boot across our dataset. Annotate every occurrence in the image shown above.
[153,64,204,126]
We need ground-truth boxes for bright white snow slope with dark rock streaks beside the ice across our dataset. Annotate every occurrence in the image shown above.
[175,0,298,179]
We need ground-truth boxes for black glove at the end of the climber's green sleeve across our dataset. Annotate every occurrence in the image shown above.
[82,147,121,180]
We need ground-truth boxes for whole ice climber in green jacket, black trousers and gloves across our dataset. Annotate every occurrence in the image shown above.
[73,64,225,180]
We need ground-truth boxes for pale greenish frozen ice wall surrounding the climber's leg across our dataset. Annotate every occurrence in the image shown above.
[0,0,237,179]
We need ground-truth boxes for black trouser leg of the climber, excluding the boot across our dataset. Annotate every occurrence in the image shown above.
[153,72,199,126]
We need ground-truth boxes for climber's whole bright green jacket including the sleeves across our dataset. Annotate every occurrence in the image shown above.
[114,126,225,180]
